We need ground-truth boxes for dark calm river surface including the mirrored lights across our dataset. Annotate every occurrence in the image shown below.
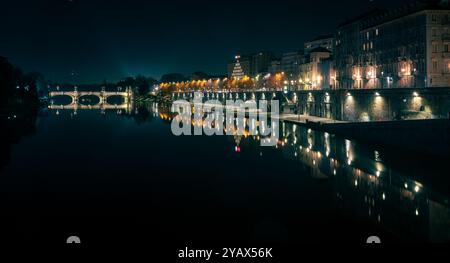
[0,105,450,246]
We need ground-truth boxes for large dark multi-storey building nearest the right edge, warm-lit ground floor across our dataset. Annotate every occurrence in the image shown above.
[334,1,450,89]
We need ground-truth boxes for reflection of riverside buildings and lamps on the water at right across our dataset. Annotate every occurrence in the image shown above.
[280,123,450,242]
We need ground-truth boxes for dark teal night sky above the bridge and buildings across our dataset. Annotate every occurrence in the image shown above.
[0,0,411,83]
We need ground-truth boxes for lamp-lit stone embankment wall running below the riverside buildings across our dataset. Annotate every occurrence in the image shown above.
[173,88,450,121]
